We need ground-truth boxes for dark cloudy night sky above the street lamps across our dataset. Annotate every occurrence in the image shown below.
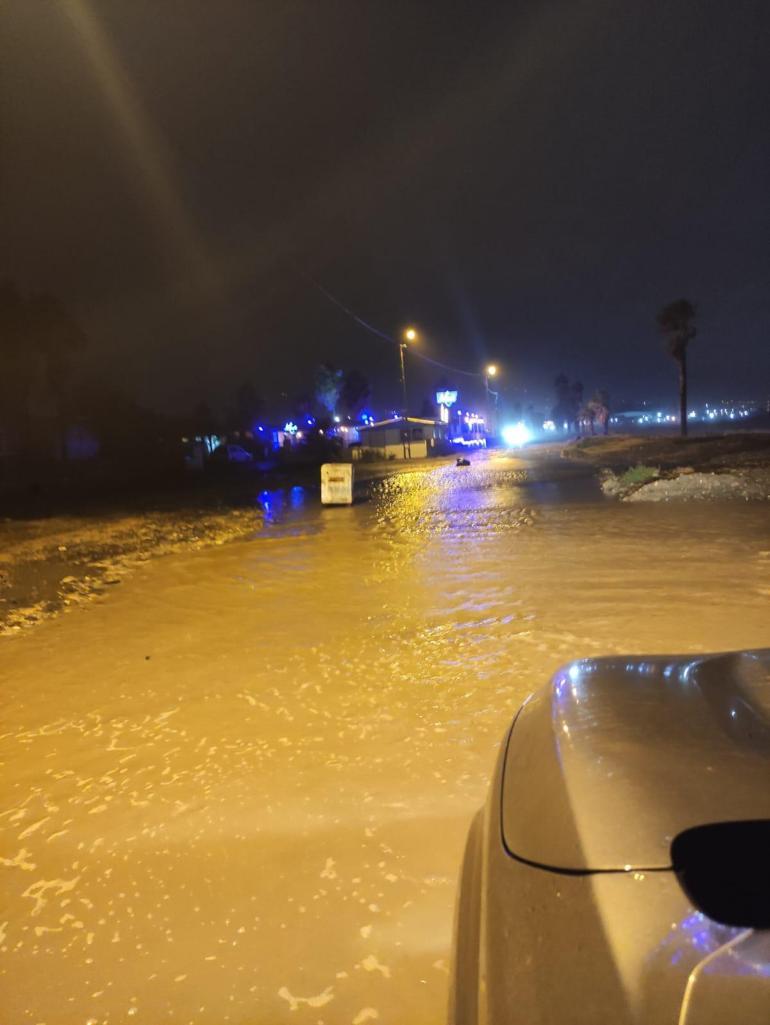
[0,0,770,416]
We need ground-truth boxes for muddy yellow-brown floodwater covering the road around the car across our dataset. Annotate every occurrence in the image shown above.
[0,459,770,1025]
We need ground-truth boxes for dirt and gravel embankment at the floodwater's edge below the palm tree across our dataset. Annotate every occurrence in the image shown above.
[562,432,770,502]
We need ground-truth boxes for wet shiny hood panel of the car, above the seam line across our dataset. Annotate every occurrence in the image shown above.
[501,649,770,871]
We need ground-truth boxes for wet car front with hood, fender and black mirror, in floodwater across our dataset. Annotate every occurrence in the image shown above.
[449,649,770,1025]
